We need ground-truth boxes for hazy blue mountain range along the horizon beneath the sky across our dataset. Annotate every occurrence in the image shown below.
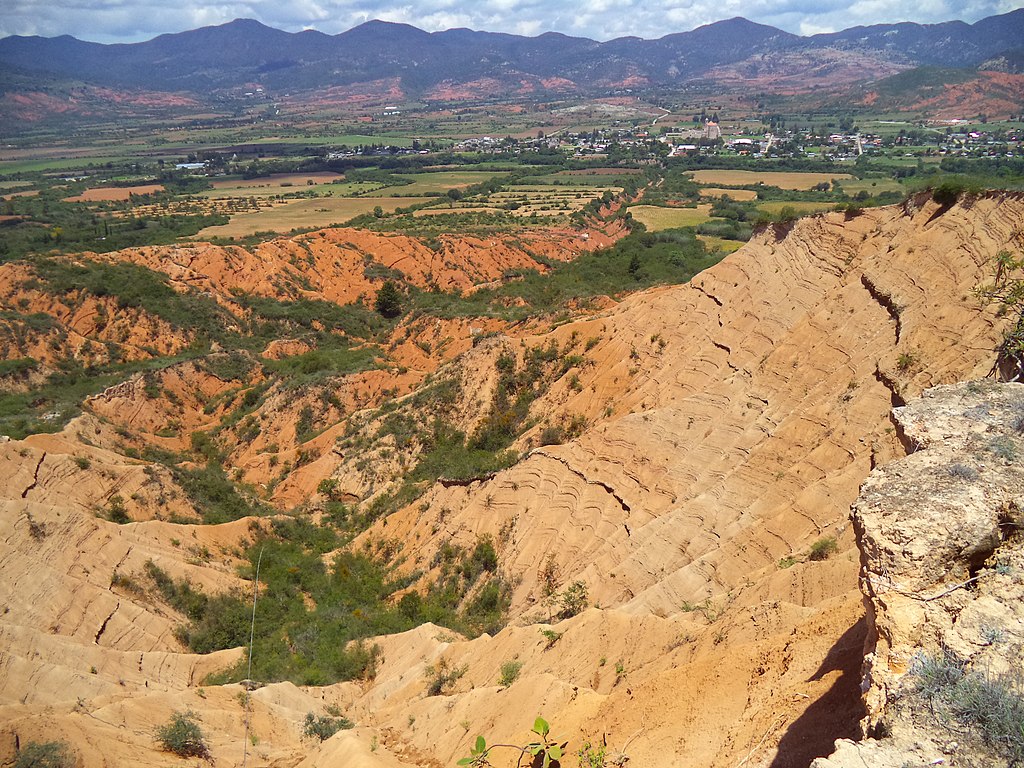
[0,9,1024,95]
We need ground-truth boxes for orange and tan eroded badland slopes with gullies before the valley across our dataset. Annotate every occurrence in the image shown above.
[6,193,1024,768]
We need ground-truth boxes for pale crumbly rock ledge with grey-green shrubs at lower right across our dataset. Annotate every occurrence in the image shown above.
[813,381,1024,768]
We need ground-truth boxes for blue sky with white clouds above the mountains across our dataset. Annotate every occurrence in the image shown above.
[0,0,1024,43]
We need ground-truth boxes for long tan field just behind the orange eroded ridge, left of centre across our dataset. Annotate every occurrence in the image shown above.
[196,198,431,240]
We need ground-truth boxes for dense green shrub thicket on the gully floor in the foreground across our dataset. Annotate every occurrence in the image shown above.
[157,519,510,685]
